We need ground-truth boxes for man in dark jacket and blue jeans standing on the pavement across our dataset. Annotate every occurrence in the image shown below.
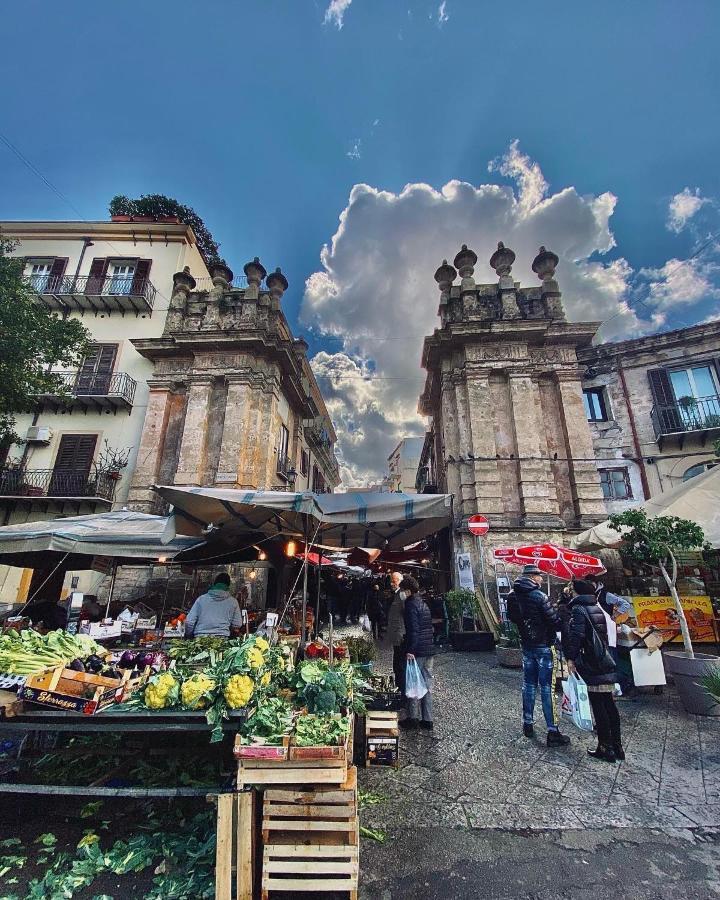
[507,565,570,747]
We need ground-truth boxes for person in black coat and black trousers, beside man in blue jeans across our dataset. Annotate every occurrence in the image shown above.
[562,581,625,762]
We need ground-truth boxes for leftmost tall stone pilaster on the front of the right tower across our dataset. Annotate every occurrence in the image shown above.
[458,369,505,522]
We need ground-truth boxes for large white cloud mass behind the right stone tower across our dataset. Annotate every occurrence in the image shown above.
[301,142,652,484]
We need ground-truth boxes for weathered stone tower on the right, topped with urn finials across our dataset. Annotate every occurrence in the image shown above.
[419,243,605,584]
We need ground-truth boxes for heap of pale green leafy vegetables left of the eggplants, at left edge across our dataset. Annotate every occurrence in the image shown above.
[0,630,105,675]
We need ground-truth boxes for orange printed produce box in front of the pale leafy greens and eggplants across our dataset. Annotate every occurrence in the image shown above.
[18,666,145,716]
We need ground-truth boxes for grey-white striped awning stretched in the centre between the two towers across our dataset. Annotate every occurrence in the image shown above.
[155,487,452,549]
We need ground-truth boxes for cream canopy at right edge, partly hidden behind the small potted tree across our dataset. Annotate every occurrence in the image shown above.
[571,466,720,550]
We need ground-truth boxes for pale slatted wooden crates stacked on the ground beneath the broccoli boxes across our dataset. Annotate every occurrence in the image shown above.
[261,767,360,900]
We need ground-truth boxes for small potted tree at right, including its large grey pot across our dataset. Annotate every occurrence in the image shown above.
[609,509,720,716]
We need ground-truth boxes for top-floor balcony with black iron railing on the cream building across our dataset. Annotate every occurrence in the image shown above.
[23,275,156,314]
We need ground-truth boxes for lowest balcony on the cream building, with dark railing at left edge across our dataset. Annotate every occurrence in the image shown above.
[0,469,118,504]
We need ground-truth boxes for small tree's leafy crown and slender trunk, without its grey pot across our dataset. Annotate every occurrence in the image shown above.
[608,509,711,657]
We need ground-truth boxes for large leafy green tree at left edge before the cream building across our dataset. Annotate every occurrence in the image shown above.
[0,237,90,446]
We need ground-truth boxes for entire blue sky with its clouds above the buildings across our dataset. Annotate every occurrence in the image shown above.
[0,0,720,483]
